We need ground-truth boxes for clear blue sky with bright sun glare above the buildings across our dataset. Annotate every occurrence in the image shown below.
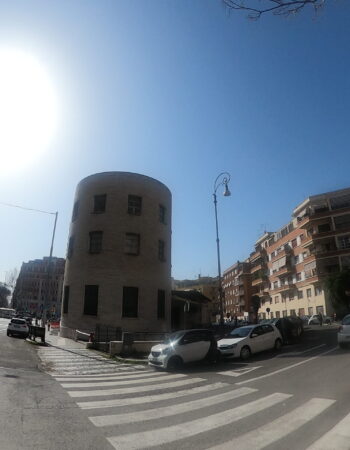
[0,0,350,281]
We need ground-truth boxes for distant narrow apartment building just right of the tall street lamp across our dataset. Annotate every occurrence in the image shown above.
[222,260,252,319]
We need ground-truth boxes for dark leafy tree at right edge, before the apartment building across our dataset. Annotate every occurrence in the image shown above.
[323,269,350,315]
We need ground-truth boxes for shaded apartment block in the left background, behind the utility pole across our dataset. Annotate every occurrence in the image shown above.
[12,257,65,317]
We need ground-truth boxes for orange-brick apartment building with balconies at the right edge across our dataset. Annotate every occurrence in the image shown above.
[259,188,350,318]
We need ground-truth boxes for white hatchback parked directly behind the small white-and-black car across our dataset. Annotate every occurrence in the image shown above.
[218,324,282,360]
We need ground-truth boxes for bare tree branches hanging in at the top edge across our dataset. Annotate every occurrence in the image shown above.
[222,0,326,20]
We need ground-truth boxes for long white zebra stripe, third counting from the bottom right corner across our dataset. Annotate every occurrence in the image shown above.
[107,393,291,450]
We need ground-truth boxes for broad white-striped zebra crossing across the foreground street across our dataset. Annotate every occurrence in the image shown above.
[47,360,350,450]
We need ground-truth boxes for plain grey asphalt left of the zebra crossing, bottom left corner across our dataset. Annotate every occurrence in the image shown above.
[0,319,111,450]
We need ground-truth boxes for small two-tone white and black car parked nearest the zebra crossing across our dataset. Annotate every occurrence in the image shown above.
[148,329,219,370]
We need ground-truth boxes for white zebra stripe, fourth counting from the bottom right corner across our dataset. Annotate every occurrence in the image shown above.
[89,388,257,427]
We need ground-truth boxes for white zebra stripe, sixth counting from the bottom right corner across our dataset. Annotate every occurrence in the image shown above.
[67,378,205,397]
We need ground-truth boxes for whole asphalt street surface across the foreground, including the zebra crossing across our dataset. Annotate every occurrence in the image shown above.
[0,318,350,450]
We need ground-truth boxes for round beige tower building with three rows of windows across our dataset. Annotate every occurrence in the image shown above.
[61,172,171,337]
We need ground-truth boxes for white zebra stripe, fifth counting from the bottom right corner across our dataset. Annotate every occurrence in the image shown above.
[77,383,229,409]
